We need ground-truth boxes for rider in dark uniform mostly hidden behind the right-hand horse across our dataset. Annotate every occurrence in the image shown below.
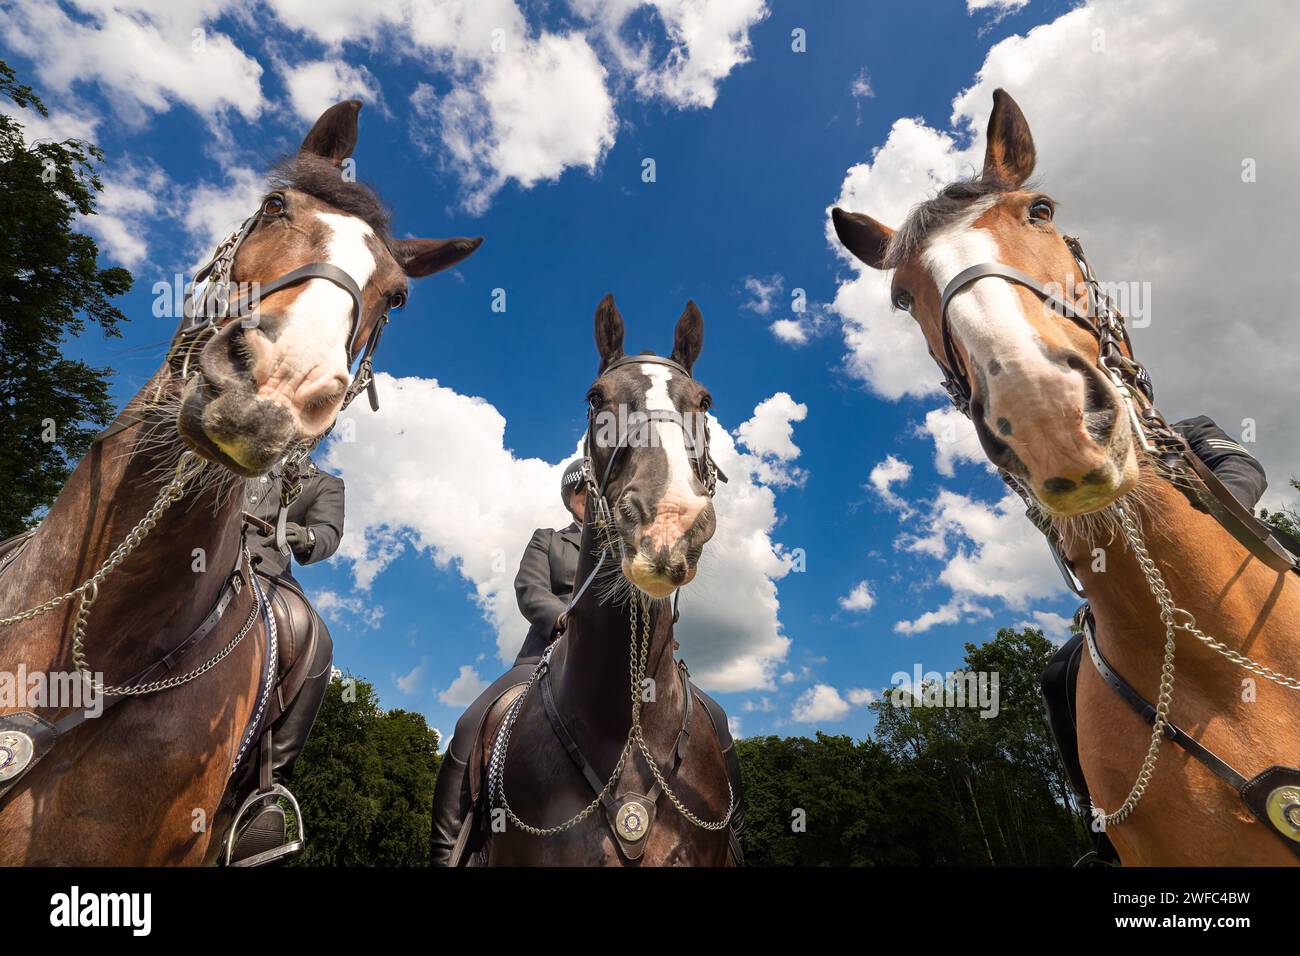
[1040,415,1269,862]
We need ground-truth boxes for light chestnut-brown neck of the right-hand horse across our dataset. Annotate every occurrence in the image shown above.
[1066,475,1300,700]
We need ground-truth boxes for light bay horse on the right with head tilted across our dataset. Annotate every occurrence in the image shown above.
[832,90,1300,865]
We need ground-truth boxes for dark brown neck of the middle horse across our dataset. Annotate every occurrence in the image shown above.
[551,523,683,745]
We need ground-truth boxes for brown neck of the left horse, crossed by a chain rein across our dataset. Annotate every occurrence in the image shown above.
[15,382,242,683]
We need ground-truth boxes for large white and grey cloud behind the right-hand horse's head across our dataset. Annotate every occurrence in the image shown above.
[827,0,1300,488]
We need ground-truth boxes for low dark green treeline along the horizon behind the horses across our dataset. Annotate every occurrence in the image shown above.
[291,630,1088,866]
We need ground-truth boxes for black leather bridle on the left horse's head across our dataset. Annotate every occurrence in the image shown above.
[168,193,389,411]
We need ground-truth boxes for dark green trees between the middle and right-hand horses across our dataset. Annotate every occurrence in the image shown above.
[737,630,1089,866]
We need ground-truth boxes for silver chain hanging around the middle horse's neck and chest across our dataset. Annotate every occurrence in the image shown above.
[488,594,736,836]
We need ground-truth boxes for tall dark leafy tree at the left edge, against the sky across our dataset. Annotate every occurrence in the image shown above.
[0,61,131,538]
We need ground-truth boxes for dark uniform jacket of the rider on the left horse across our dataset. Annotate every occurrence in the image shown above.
[244,462,343,578]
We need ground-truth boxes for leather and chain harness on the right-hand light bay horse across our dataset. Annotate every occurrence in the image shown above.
[931,235,1300,856]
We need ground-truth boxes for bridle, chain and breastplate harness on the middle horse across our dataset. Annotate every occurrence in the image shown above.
[480,354,744,861]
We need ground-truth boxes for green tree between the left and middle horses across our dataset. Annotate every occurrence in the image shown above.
[290,678,439,866]
